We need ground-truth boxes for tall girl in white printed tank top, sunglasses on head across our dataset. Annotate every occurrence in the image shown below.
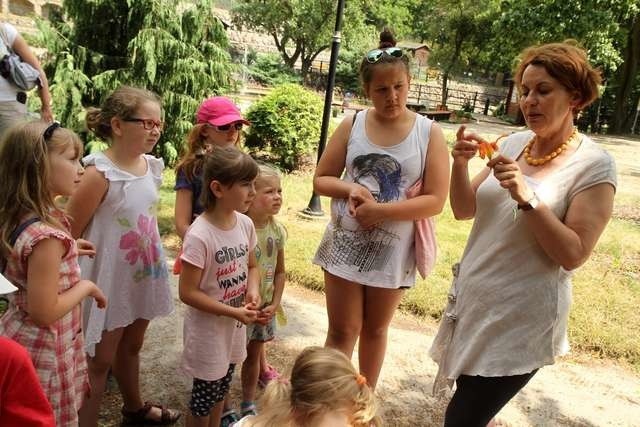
[314,30,449,387]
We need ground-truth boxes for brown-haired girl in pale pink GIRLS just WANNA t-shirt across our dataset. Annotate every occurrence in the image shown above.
[179,147,260,427]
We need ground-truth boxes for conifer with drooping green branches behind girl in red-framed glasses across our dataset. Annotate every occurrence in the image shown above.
[33,0,233,164]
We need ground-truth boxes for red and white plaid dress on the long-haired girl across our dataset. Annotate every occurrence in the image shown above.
[0,212,89,427]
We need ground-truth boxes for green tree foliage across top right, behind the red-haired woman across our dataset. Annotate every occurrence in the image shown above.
[402,0,640,132]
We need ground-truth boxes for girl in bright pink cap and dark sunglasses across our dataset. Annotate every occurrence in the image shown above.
[174,96,249,241]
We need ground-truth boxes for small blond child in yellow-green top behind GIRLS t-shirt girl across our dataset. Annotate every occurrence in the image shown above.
[240,164,287,416]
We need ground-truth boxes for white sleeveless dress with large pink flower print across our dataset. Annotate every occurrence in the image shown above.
[80,153,173,356]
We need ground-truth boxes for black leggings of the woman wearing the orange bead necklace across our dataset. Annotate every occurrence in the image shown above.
[444,369,538,427]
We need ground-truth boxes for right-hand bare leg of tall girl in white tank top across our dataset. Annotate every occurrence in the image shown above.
[358,286,404,389]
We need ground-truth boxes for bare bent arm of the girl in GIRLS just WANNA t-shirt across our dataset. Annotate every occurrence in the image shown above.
[178,260,255,323]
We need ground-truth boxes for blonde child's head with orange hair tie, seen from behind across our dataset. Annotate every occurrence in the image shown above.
[235,347,382,427]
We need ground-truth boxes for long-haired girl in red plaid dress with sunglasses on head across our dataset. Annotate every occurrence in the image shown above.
[0,118,106,427]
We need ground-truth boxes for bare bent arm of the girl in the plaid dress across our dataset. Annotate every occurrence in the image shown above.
[27,238,106,326]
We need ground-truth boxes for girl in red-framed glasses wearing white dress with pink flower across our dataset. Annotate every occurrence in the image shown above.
[68,86,180,426]
